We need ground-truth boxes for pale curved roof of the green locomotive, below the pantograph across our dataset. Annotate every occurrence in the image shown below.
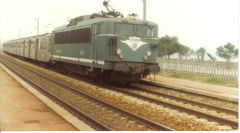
[53,15,157,32]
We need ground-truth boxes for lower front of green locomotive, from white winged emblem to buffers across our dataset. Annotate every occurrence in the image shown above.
[114,36,160,75]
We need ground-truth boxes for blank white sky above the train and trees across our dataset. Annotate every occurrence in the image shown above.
[0,0,239,58]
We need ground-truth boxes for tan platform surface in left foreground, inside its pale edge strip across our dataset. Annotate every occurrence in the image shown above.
[0,66,77,131]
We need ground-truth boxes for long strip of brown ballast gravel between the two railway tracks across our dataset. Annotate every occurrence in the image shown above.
[3,54,234,131]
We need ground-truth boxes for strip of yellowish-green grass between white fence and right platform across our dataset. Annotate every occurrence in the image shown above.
[159,72,238,88]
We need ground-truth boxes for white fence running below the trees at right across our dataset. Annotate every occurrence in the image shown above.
[157,58,238,80]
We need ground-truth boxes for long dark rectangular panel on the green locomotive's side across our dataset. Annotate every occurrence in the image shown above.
[54,27,92,44]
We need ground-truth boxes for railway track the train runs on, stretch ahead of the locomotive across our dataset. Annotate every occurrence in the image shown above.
[107,84,238,129]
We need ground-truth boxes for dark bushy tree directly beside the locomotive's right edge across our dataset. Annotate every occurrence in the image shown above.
[158,35,180,58]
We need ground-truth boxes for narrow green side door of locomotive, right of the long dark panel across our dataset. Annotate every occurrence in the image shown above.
[91,24,98,64]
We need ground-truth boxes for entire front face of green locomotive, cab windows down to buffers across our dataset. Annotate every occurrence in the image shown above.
[102,20,160,81]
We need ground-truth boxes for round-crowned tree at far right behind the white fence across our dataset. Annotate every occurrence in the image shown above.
[216,43,238,62]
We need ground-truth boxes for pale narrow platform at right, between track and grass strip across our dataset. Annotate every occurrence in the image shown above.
[146,75,238,97]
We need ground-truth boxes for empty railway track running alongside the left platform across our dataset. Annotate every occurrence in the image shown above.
[0,57,173,131]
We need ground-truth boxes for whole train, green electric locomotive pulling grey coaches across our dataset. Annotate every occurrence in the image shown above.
[3,1,160,83]
